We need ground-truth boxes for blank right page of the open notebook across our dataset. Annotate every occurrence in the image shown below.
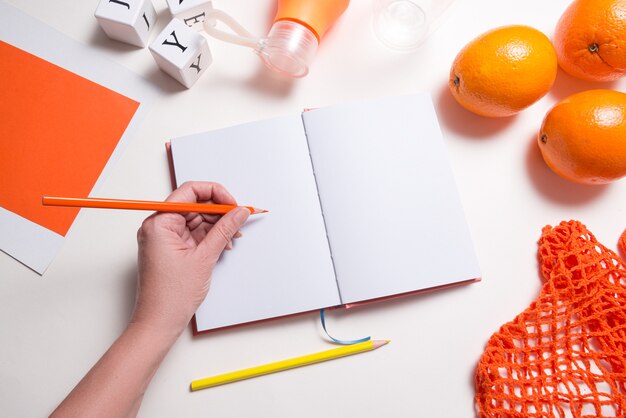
[302,95,480,303]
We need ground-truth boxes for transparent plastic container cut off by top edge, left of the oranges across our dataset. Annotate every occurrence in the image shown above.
[372,0,454,52]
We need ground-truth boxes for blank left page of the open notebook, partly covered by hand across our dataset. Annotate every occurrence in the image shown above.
[171,115,340,331]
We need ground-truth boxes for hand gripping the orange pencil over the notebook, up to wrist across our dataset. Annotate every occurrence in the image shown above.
[131,182,250,335]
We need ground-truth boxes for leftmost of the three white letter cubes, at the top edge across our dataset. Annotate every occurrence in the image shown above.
[95,0,157,48]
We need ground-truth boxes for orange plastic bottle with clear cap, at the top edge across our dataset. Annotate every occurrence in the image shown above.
[258,0,350,77]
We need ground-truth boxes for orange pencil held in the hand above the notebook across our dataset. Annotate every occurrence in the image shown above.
[42,196,267,215]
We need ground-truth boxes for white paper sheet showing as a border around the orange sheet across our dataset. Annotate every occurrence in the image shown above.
[0,1,158,274]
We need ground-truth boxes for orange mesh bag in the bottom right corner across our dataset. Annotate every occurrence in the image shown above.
[475,221,626,418]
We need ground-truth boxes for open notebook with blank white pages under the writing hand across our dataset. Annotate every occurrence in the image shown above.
[170,95,480,332]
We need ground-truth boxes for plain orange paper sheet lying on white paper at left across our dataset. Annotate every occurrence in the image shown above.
[0,41,139,236]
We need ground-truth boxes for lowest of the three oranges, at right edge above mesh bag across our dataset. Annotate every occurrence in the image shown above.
[537,90,626,184]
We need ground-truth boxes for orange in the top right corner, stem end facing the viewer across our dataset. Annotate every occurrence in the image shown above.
[554,0,626,81]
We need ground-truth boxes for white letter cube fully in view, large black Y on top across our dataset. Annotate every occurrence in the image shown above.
[150,19,211,88]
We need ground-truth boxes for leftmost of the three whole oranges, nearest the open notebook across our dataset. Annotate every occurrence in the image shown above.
[449,25,558,117]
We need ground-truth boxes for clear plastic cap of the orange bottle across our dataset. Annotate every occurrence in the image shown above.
[257,20,319,78]
